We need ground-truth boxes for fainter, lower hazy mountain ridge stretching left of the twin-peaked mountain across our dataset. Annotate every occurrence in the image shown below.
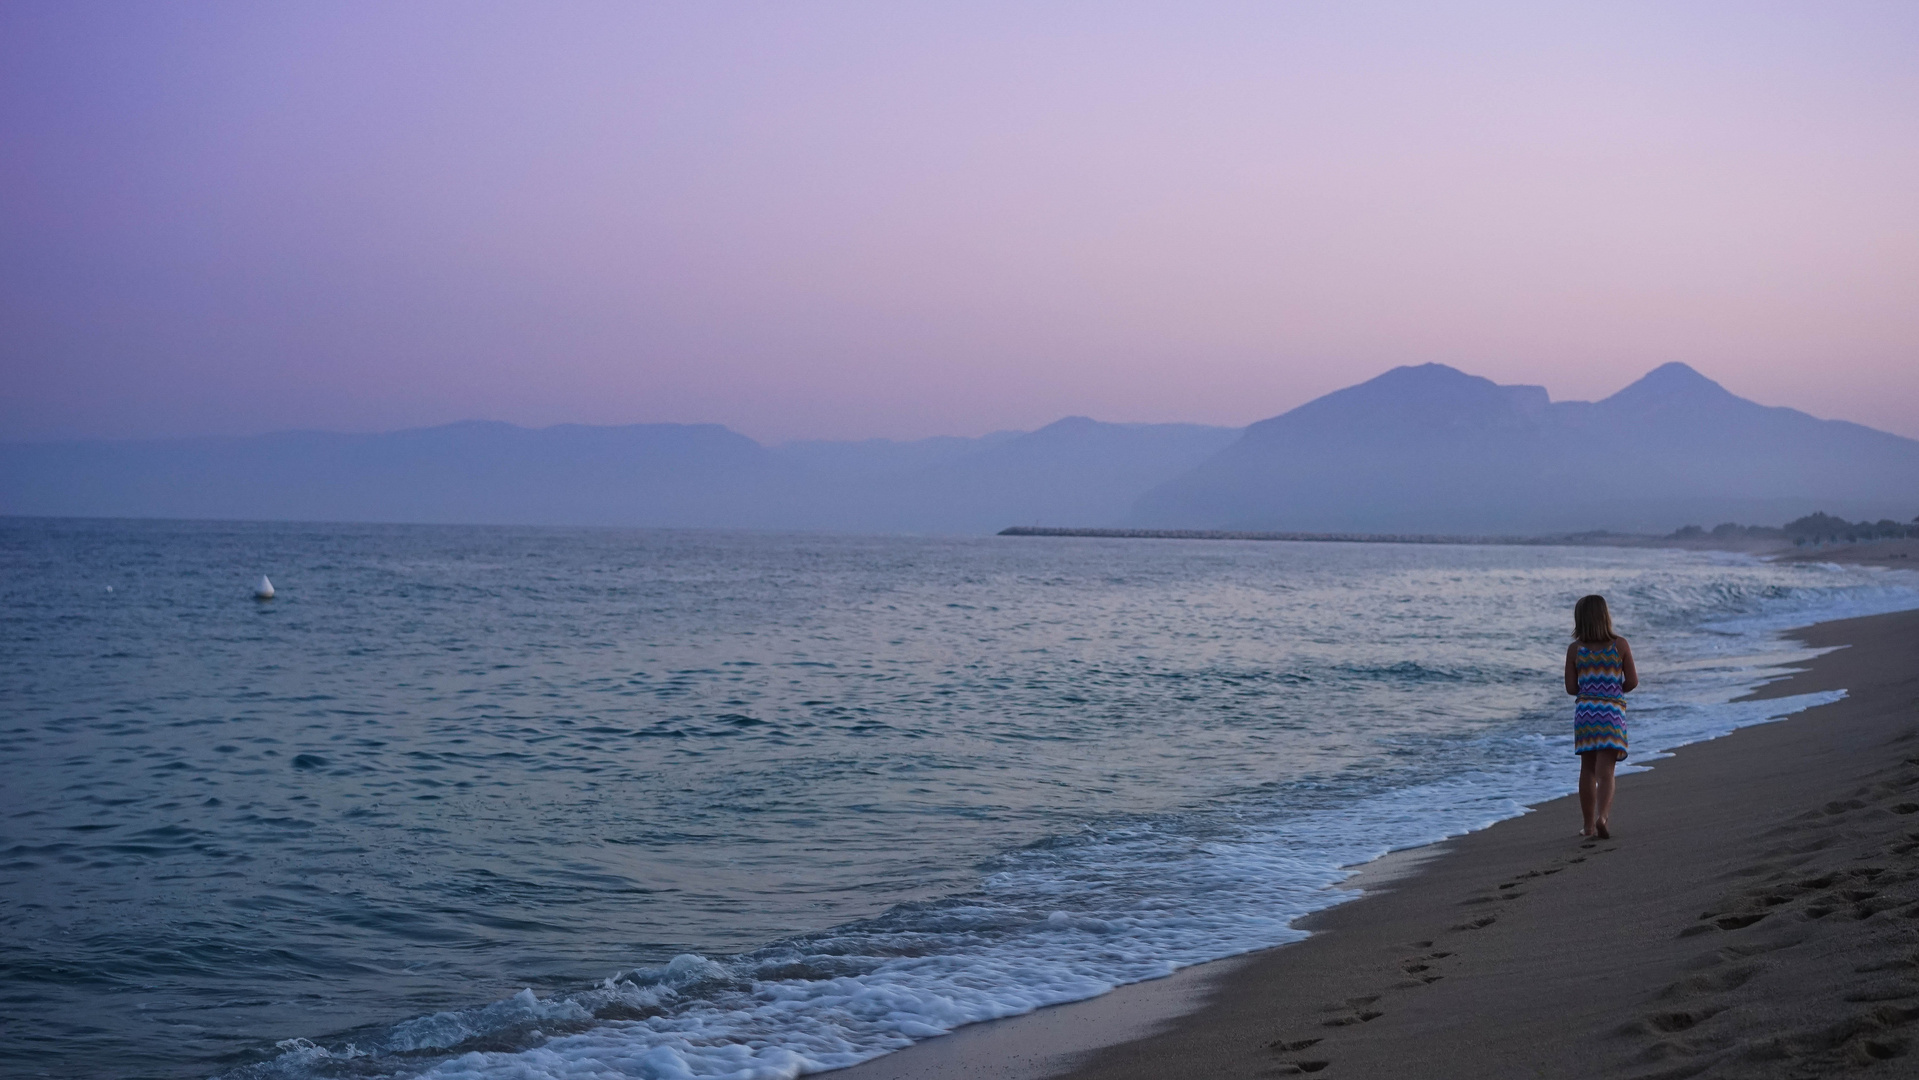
[0,418,1238,533]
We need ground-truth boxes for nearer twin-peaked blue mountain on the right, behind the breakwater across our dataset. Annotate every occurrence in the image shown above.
[1132,364,1919,533]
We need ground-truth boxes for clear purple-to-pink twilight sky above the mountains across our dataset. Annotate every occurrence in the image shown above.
[0,0,1919,441]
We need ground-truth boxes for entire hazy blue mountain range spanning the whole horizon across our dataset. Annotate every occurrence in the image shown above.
[0,363,1919,535]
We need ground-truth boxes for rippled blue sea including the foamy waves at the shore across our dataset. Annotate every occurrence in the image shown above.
[0,518,1919,1080]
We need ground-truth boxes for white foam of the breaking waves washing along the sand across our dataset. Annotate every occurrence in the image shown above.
[408,691,1844,1080]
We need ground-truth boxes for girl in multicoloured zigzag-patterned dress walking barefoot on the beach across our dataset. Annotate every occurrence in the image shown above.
[1566,595,1639,840]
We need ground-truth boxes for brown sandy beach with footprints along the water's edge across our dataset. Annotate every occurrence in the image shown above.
[839,612,1919,1080]
